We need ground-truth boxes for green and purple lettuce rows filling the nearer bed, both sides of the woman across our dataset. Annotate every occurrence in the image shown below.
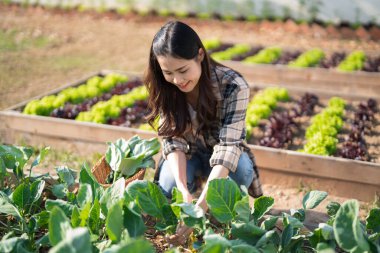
[17,74,380,163]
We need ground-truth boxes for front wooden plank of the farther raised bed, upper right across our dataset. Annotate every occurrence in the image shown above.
[222,61,380,98]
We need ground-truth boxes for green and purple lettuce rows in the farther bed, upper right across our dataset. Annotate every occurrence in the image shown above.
[204,39,380,72]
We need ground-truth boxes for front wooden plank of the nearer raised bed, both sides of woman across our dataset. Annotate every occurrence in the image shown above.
[0,111,380,185]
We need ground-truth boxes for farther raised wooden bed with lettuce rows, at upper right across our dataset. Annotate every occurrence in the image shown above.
[205,40,380,97]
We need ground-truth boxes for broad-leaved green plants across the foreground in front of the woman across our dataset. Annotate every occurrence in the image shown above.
[0,141,380,252]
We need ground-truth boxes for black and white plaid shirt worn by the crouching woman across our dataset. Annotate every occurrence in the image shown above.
[162,66,262,195]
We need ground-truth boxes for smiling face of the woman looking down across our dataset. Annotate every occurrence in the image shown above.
[157,49,204,93]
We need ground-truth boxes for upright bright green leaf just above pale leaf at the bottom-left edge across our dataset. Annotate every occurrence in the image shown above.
[49,206,72,246]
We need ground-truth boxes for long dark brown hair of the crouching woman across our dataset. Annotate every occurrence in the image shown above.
[144,21,216,137]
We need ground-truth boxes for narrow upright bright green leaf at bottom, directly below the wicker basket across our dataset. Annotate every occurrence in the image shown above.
[106,201,124,243]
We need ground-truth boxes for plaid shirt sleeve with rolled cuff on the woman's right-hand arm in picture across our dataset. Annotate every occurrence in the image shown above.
[210,76,249,172]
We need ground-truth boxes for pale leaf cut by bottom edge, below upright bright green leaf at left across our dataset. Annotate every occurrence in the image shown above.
[49,228,92,253]
